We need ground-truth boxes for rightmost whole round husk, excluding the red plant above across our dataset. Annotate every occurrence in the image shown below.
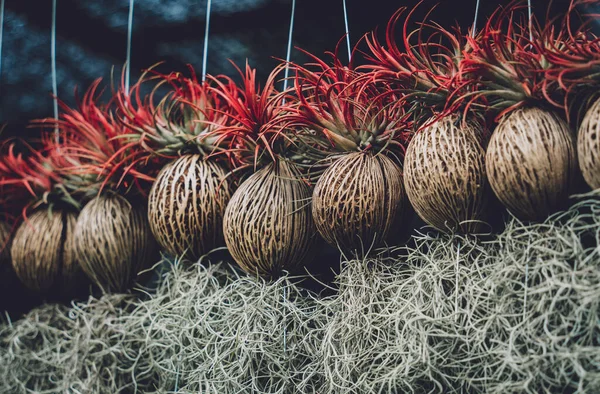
[485,108,577,221]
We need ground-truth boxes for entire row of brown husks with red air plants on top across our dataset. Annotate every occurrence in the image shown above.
[0,0,600,291]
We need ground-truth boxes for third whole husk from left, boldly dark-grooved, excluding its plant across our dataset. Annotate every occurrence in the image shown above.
[148,155,232,259]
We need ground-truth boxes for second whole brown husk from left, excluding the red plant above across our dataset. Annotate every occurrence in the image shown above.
[75,193,158,292]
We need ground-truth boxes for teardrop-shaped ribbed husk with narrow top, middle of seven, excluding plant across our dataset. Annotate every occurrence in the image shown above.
[223,160,316,278]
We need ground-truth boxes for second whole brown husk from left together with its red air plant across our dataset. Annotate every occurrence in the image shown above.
[42,79,157,291]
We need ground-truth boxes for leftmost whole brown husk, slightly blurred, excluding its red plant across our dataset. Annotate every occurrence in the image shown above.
[10,208,81,293]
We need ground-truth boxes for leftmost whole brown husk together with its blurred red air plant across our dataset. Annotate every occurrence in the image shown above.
[0,134,82,295]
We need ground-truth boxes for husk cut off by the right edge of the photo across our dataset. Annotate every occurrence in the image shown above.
[577,95,600,189]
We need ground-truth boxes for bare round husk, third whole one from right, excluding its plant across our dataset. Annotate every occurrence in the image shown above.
[312,152,406,252]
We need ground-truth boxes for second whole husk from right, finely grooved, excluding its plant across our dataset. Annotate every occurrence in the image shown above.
[404,116,491,233]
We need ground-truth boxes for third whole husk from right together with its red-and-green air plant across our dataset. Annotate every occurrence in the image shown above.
[286,43,409,253]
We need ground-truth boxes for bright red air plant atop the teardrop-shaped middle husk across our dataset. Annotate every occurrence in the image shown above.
[209,63,293,168]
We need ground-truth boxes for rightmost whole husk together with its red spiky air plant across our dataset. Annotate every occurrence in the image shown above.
[459,1,576,220]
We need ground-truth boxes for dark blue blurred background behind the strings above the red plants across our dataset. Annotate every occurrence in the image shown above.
[0,0,580,316]
